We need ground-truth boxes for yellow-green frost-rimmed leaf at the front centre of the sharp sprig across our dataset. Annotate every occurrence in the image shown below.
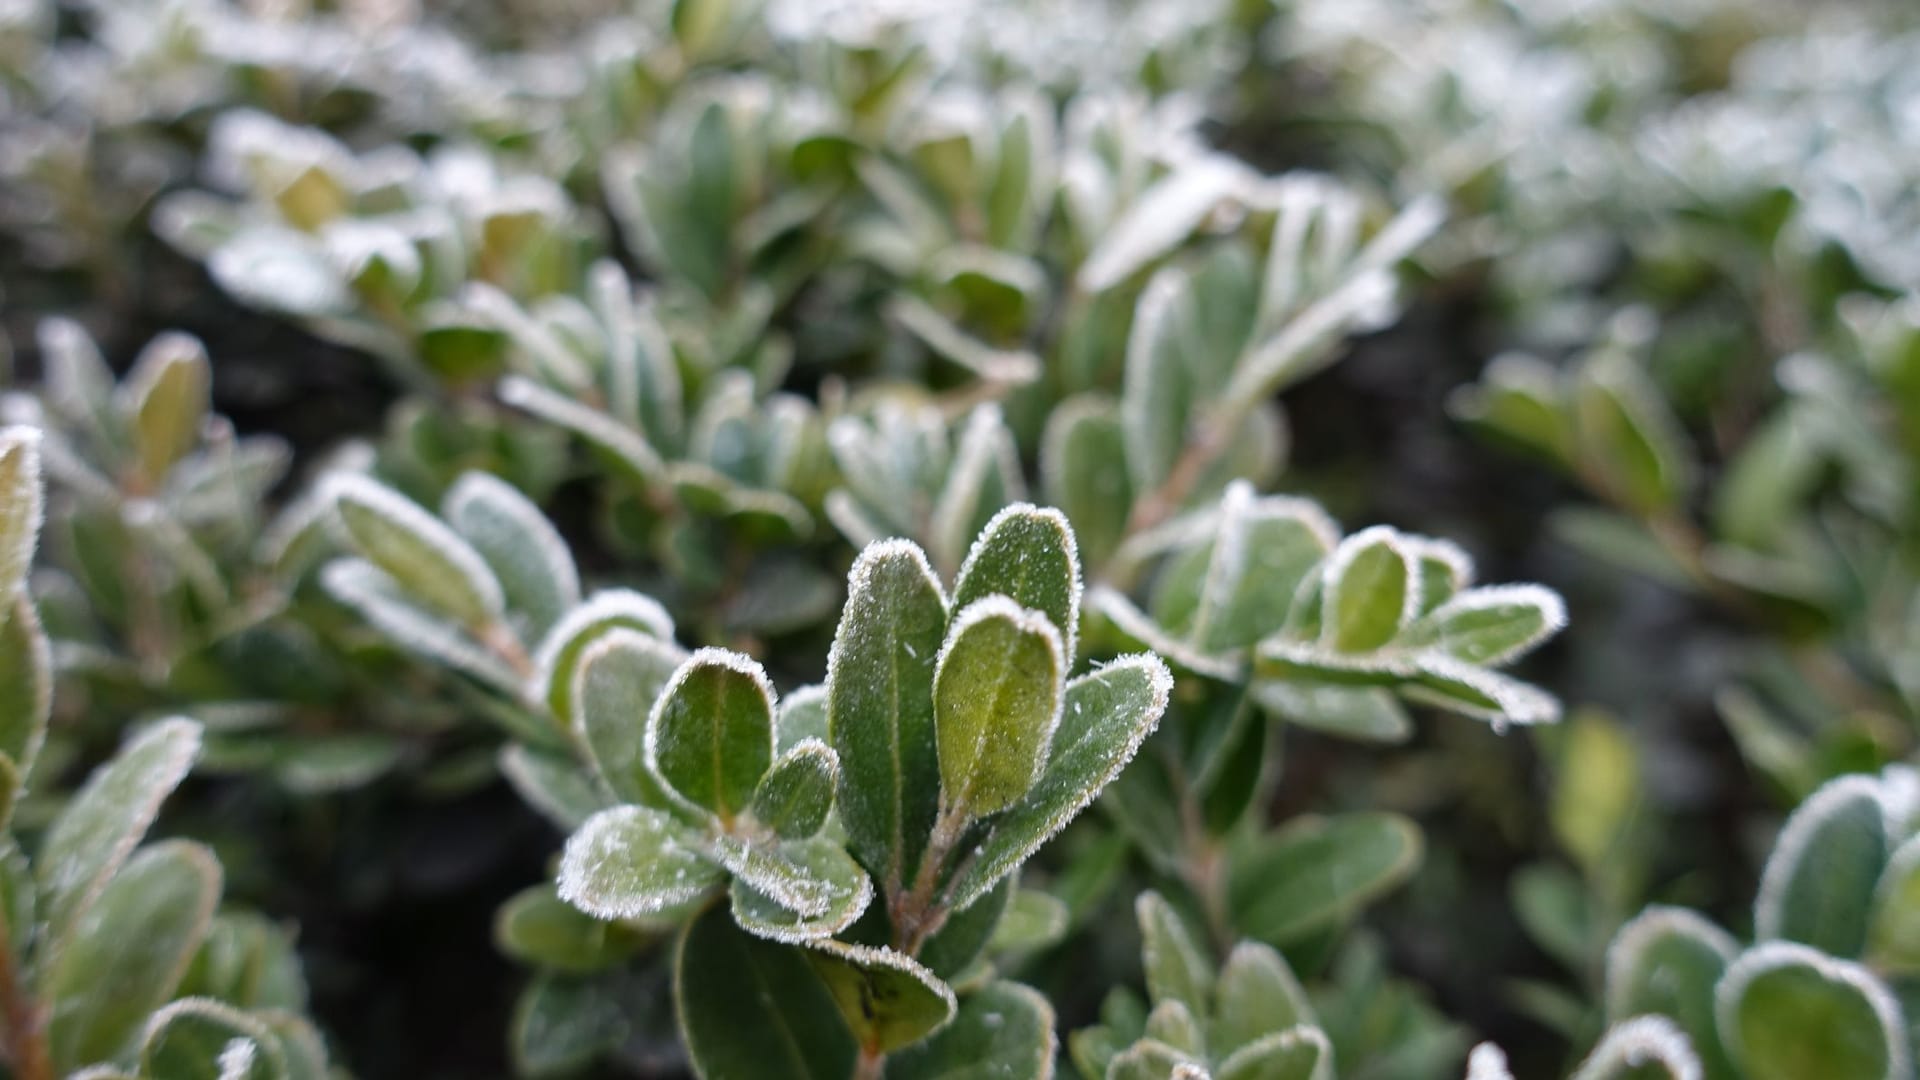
[933,596,1066,819]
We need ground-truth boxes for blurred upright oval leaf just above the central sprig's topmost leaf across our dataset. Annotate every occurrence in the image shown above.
[1041,394,1133,567]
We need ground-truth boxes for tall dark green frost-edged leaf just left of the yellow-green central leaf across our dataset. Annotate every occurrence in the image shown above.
[826,540,947,894]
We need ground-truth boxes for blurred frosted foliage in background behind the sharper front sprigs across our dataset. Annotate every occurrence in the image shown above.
[0,0,1920,1078]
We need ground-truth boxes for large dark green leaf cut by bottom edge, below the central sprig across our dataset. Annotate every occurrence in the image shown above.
[674,909,856,1080]
